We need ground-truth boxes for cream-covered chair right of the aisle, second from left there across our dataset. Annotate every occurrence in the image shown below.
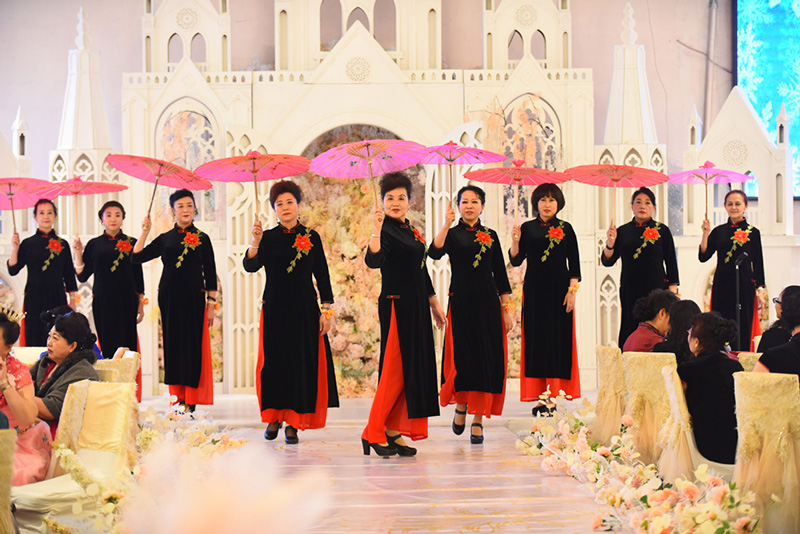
[622,352,678,472]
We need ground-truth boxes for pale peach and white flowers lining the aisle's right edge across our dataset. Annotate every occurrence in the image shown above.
[516,395,761,534]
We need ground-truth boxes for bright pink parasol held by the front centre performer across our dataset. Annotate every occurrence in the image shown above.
[309,139,427,208]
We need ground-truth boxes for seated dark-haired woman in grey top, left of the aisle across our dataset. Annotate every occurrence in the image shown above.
[31,312,99,435]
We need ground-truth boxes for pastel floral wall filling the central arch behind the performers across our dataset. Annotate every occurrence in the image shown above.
[297,124,425,397]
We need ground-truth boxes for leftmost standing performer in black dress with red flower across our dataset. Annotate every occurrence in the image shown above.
[8,199,78,347]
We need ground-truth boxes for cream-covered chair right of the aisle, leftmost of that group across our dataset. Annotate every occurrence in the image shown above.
[589,345,625,445]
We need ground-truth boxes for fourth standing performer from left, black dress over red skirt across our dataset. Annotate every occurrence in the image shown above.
[244,181,339,444]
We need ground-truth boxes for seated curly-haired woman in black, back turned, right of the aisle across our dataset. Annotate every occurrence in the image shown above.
[678,312,744,464]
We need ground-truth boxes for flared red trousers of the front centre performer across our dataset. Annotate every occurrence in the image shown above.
[361,302,428,443]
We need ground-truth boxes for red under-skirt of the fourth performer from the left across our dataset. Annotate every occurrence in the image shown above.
[256,310,328,430]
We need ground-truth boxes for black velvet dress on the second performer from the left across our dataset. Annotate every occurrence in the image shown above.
[78,232,144,358]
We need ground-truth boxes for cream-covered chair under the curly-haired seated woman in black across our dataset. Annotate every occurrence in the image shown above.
[658,367,733,483]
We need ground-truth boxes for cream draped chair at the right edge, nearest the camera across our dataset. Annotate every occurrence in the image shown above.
[733,371,800,534]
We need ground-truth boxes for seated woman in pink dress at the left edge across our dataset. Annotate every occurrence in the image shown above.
[0,307,51,486]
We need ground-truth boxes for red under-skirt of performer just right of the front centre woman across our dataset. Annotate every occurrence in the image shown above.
[439,306,508,417]
